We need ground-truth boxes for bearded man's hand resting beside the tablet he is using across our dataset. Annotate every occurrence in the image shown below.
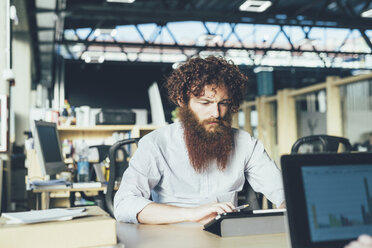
[190,202,235,225]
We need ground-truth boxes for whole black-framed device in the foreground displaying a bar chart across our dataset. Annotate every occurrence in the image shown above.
[281,153,372,248]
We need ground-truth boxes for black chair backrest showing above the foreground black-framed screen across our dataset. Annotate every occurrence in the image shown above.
[291,135,352,154]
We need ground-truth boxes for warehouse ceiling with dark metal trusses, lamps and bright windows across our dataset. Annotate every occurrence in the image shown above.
[27,0,372,86]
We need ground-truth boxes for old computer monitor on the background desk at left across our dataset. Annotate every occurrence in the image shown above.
[34,121,67,178]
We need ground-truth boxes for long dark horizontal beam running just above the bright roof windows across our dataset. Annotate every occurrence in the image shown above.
[62,5,372,29]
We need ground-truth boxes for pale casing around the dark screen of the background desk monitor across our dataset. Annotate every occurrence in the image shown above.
[33,120,67,177]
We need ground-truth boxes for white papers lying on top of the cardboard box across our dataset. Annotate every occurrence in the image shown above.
[1,208,86,224]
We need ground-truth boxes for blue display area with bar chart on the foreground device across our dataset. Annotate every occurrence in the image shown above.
[301,164,372,242]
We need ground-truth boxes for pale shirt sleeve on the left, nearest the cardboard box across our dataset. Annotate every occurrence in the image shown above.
[114,137,161,223]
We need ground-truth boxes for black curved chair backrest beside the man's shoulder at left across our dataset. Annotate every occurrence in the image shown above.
[105,138,140,216]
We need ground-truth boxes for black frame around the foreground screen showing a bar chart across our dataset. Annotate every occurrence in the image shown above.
[281,153,372,248]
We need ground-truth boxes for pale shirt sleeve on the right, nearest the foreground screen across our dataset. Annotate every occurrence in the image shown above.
[245,138,284,206]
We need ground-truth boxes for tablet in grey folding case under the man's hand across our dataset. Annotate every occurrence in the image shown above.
[204,209,286,237]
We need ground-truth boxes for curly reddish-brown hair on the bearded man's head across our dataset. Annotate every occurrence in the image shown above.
[166,56,248,112]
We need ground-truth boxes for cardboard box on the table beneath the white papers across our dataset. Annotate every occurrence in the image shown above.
[0,206,117,248]
